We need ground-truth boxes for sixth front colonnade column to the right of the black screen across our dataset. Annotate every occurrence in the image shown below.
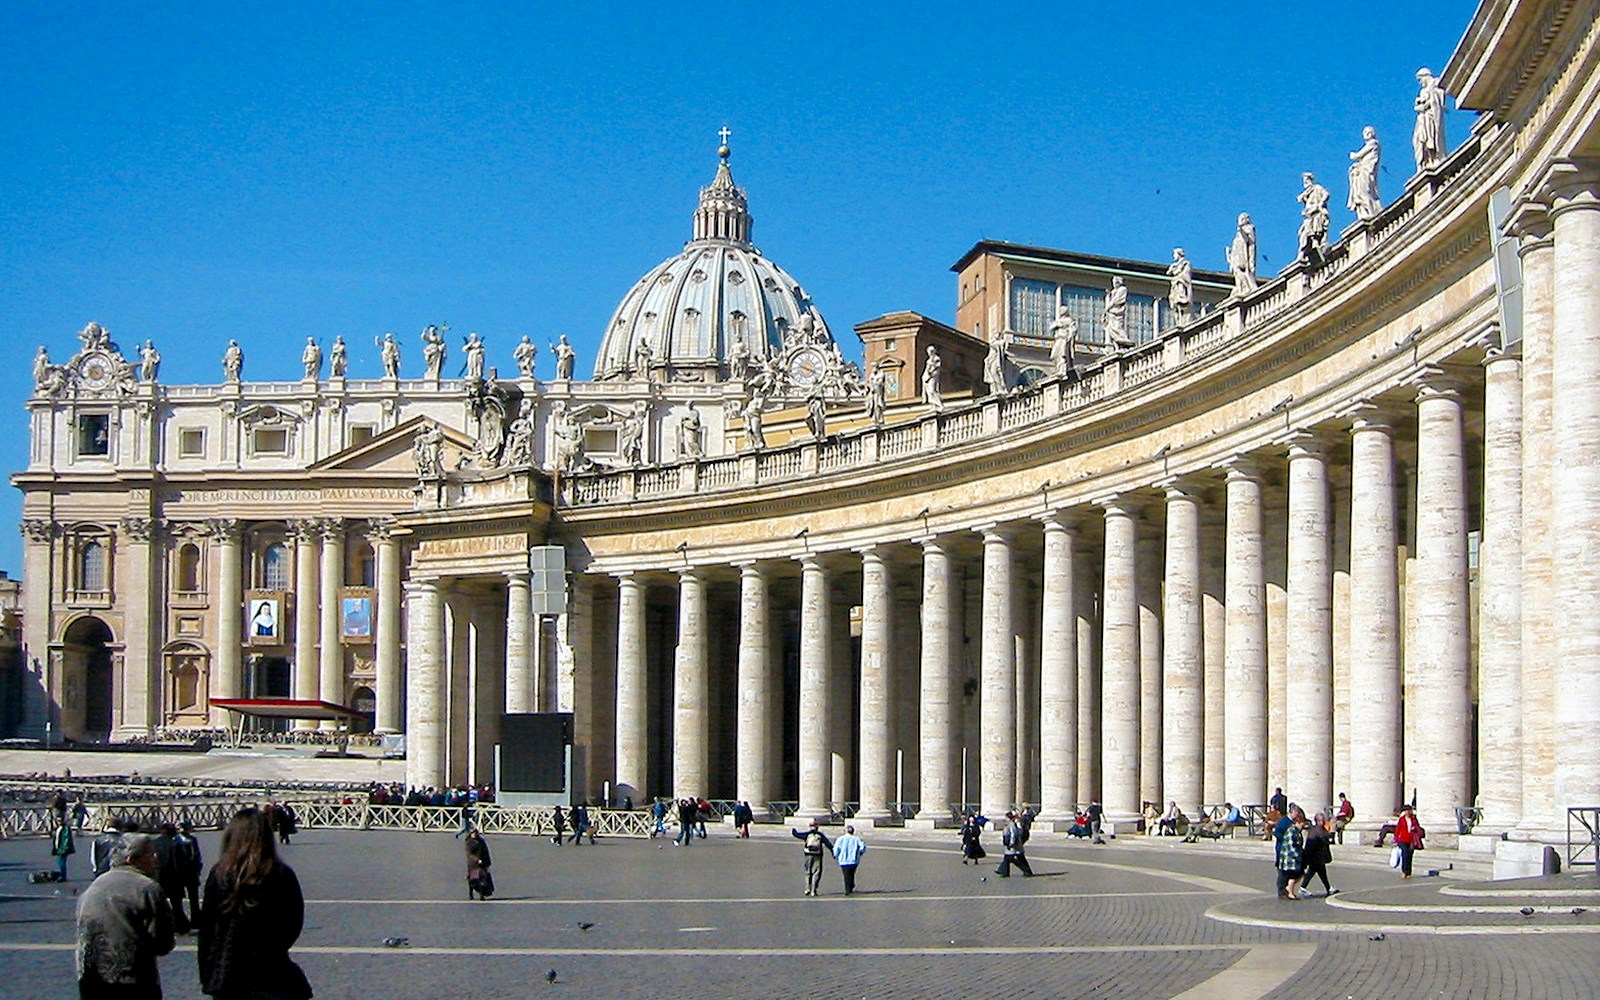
[920,538,960,816]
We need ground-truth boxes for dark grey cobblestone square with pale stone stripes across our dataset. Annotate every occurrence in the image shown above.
[0,829,1600,1000]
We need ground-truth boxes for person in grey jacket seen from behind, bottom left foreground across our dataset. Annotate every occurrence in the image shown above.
[77,834,174,1000]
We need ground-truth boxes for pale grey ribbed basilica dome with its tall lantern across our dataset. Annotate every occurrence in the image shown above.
[594,146,832,382]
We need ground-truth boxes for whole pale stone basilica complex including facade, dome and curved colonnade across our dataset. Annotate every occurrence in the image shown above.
[13,0,1600,862]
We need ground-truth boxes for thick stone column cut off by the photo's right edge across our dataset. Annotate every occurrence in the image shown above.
[1546,160,1600,816]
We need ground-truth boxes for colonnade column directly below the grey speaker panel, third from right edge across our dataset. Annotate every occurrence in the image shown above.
[1478,347,1523,832]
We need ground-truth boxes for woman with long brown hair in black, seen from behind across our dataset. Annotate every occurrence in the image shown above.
[195,808,312,1000]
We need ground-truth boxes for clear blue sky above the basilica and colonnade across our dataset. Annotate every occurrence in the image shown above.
[0,0,1474,574]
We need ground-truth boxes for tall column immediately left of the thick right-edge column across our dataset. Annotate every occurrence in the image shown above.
[1516,202,1566,837]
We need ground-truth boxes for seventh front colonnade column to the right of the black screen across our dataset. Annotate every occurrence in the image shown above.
[979,525,1016,816]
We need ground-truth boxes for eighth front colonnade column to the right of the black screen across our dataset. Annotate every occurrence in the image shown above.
[1038,510,1078,822]
